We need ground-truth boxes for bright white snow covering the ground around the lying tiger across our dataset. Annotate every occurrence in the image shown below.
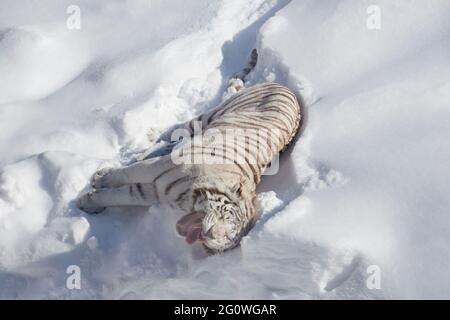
[0,0,450,299]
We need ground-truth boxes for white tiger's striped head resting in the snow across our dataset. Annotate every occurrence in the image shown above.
[177,185,257,253]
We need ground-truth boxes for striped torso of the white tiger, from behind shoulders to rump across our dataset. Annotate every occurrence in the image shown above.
[173,83,301,185]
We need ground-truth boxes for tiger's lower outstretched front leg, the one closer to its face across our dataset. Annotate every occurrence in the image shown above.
[77,183,157,213]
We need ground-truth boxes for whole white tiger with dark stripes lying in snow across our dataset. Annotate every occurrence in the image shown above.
[78,50,300,252]
